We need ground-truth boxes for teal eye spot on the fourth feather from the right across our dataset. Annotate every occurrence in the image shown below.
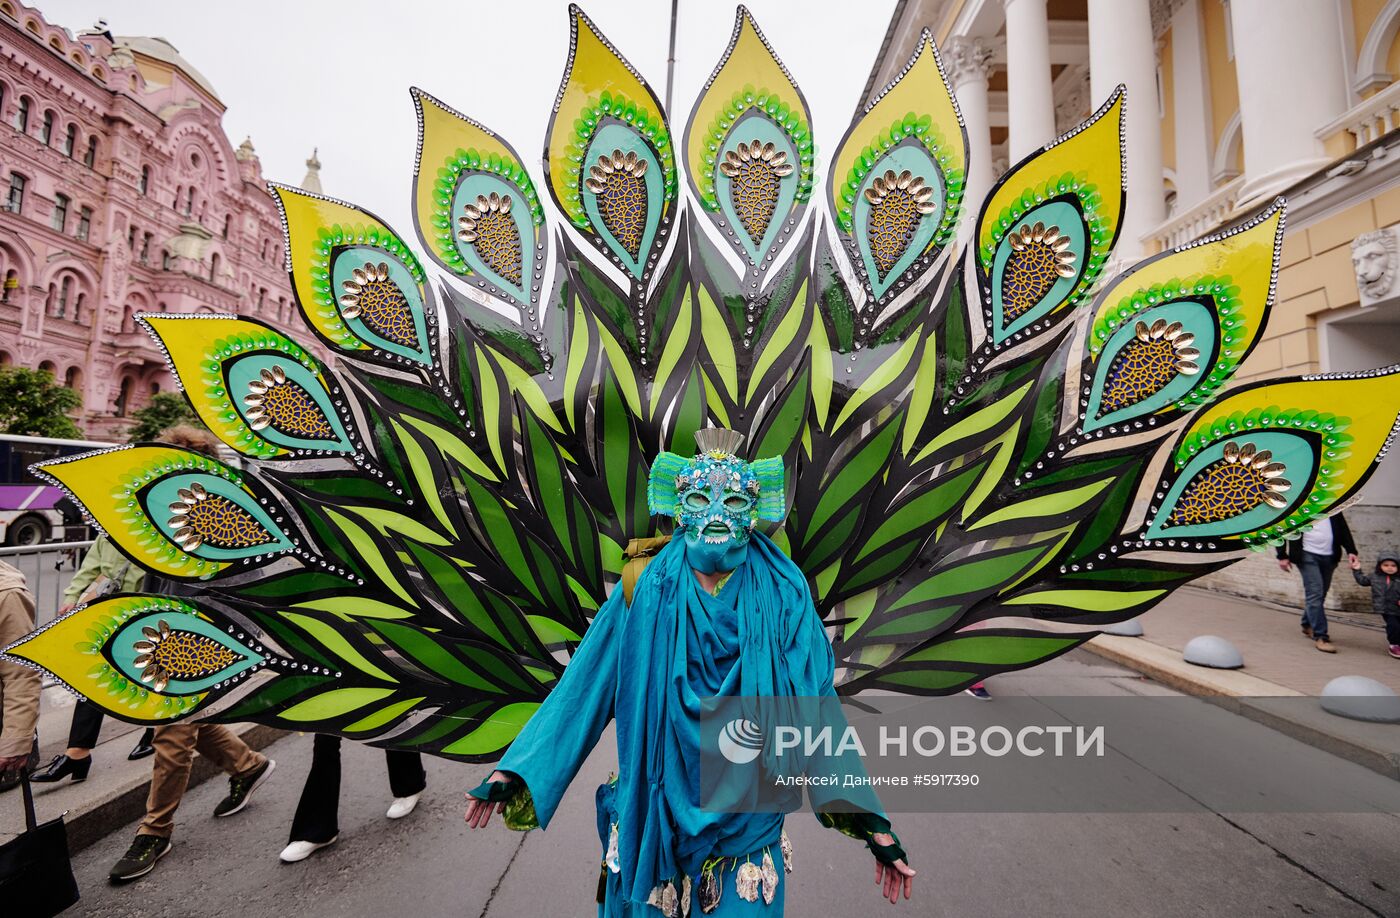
[851,139,946,299]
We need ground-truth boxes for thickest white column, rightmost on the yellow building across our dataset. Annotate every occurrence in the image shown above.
[1229,0,1347,207]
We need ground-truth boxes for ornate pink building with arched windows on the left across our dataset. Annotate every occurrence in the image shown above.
[0,0,303,439]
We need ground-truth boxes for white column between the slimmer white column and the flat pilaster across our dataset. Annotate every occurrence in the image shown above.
[1089,0,1166,257]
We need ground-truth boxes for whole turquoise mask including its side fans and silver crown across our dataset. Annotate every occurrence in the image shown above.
[647,428,784,574]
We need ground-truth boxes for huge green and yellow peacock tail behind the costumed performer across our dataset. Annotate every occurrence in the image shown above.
[8,8,1400,760]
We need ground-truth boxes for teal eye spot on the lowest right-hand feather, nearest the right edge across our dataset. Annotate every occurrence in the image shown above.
[1144,431,1316,539]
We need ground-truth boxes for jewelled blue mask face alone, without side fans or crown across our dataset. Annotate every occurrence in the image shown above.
[676,453,759,574]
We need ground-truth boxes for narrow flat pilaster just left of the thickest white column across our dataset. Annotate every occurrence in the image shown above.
[1172,0,1214,213]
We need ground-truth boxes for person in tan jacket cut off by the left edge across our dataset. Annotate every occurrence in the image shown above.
[0,561,39,791]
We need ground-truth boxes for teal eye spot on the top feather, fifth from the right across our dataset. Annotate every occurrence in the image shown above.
[714,109,799,263]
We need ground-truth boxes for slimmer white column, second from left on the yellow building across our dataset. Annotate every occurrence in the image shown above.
[1002,0,1056,162]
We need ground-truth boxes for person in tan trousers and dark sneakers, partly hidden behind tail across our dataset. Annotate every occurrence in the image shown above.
[108,425,277,883]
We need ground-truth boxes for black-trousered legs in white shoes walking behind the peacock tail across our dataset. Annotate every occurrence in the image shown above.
[279,733,427,863]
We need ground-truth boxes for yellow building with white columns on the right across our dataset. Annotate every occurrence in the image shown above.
[867,0,1400,603]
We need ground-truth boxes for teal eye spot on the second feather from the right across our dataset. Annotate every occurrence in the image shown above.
[1082,299,1218,431]
